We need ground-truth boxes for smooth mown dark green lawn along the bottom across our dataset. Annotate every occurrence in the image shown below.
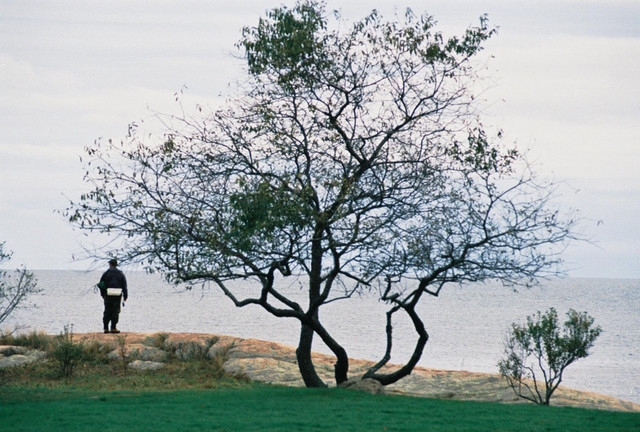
[0,384,640,432]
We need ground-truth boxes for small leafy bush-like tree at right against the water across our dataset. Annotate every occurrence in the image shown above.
[498,308,602,405]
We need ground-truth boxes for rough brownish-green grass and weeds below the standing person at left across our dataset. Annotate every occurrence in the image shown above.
[0,326,242,390]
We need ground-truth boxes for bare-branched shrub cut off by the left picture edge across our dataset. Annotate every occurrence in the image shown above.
[0,242,40,324]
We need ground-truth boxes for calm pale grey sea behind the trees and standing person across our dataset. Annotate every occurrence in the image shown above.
[3,271,640,402]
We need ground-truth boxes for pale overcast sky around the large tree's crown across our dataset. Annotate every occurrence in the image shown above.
[0,0,640,278]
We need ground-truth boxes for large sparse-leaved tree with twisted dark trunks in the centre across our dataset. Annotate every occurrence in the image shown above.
[68,0,572,386]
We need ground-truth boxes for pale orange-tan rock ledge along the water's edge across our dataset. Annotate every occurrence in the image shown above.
[75,332,640,412]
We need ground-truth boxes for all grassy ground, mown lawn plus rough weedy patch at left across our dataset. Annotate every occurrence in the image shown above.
[0,335,640,432]
